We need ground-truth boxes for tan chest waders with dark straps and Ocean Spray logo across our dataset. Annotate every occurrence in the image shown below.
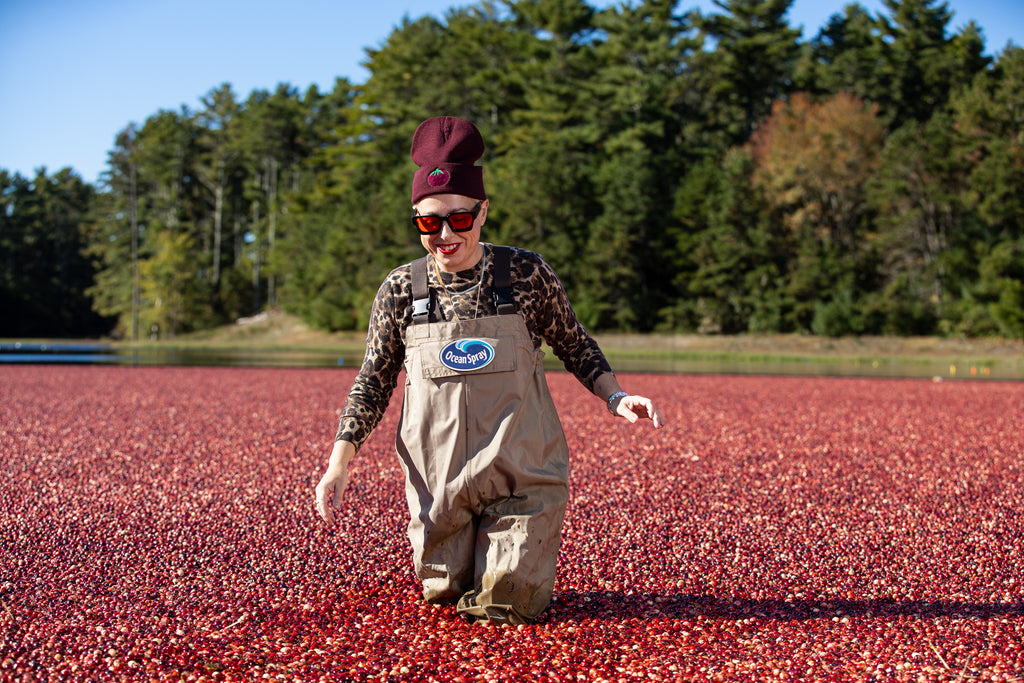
[395,247,568,624]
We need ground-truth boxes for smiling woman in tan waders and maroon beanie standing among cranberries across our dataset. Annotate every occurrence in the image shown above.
[316,117,664,624]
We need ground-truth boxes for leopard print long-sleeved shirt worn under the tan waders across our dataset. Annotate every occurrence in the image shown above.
[335,243,611,449]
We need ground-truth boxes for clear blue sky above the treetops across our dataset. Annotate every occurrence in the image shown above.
[0,0,1024,182]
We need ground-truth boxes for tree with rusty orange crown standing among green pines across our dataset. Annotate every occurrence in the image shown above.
[748,93,886,334]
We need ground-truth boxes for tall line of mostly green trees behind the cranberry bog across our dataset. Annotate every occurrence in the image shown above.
[0,0,1024,338]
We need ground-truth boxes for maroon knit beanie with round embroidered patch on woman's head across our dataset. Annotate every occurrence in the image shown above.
[411,116,487,204]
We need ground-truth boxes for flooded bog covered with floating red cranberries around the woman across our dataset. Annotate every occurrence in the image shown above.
[0,366,1024,681]
